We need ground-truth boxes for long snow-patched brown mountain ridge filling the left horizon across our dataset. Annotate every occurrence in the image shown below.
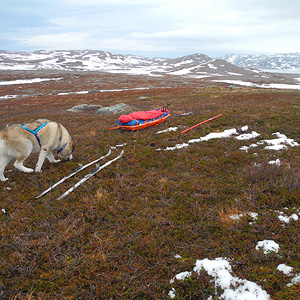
[0,50,212,74]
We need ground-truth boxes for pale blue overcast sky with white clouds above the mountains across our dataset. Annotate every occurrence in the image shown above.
[0,0,300,58]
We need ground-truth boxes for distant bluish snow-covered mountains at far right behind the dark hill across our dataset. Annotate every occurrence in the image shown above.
[221,52,300,70]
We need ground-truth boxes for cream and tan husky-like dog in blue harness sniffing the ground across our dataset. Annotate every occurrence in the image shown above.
[0,119,74,181]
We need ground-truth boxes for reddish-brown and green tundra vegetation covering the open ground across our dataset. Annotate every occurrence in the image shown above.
[0,71,300,300]
